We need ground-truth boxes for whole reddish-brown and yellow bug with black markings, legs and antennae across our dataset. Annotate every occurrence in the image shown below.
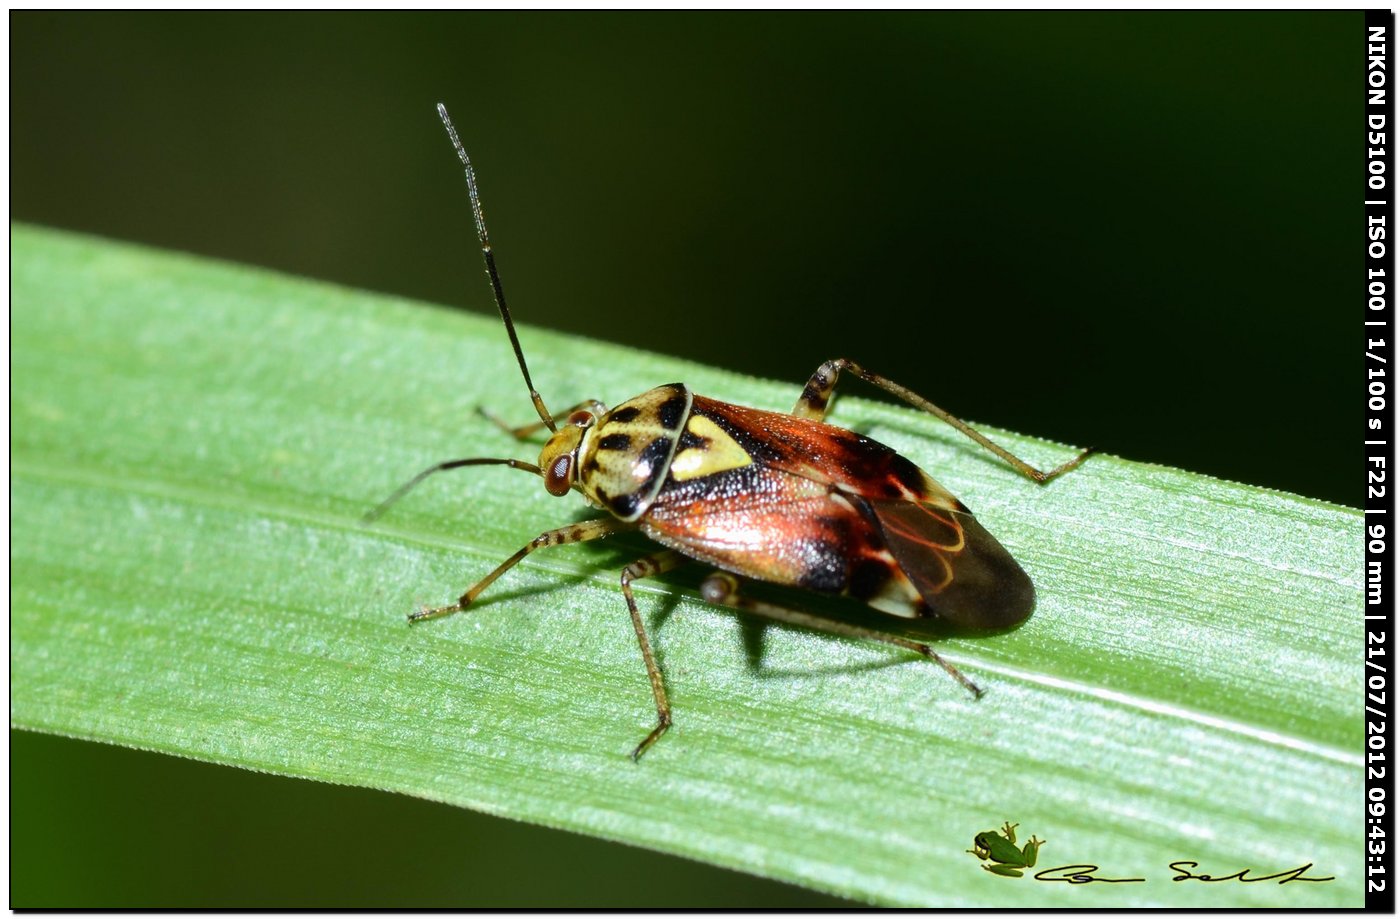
[367,104,1092,759]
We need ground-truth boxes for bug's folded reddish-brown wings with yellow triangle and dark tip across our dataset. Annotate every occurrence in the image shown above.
[638,396,1035,628]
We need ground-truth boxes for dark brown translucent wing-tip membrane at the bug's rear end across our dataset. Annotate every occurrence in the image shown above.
[867,499,1036,629]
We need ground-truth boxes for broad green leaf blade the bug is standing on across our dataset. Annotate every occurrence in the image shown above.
[11,227,1364,908]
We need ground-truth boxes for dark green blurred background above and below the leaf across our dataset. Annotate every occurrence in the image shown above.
[10,13,1364,906]
